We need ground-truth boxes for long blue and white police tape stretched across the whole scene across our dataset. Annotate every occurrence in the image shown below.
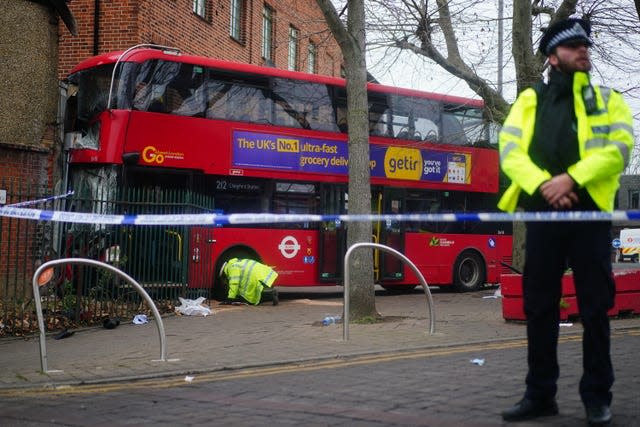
[0,206,640,225]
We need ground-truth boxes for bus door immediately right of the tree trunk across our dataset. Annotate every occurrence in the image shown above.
[372,188,405,281]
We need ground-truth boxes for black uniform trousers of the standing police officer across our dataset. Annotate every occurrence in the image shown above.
[523,222,615,407]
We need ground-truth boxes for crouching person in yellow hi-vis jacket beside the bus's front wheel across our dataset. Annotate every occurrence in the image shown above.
[220,258,278,305]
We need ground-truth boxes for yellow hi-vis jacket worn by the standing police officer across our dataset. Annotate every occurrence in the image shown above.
[498,72,634,212]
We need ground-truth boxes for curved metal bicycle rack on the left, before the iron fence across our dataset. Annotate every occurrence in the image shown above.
[33,258,167,373]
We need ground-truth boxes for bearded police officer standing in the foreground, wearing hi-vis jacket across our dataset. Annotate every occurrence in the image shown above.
[498,19,633,425]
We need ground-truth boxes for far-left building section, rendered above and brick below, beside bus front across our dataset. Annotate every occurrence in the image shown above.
[0,0,73,310]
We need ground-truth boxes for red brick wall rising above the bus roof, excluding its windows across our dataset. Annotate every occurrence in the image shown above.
[59,0,342,78]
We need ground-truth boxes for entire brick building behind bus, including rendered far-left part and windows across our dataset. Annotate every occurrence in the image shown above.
[0,0,342,326]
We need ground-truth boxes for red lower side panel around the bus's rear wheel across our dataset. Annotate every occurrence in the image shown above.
[405,233,511,285]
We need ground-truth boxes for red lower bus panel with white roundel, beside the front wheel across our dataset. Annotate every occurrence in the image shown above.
[211,228,327,286]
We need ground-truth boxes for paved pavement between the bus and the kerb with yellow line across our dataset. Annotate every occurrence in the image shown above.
[0,288,640,394]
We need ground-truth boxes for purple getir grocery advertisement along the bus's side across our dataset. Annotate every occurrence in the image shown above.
[231,131,471,184]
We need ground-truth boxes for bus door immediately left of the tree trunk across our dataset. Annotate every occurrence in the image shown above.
[318,184,348,282]
